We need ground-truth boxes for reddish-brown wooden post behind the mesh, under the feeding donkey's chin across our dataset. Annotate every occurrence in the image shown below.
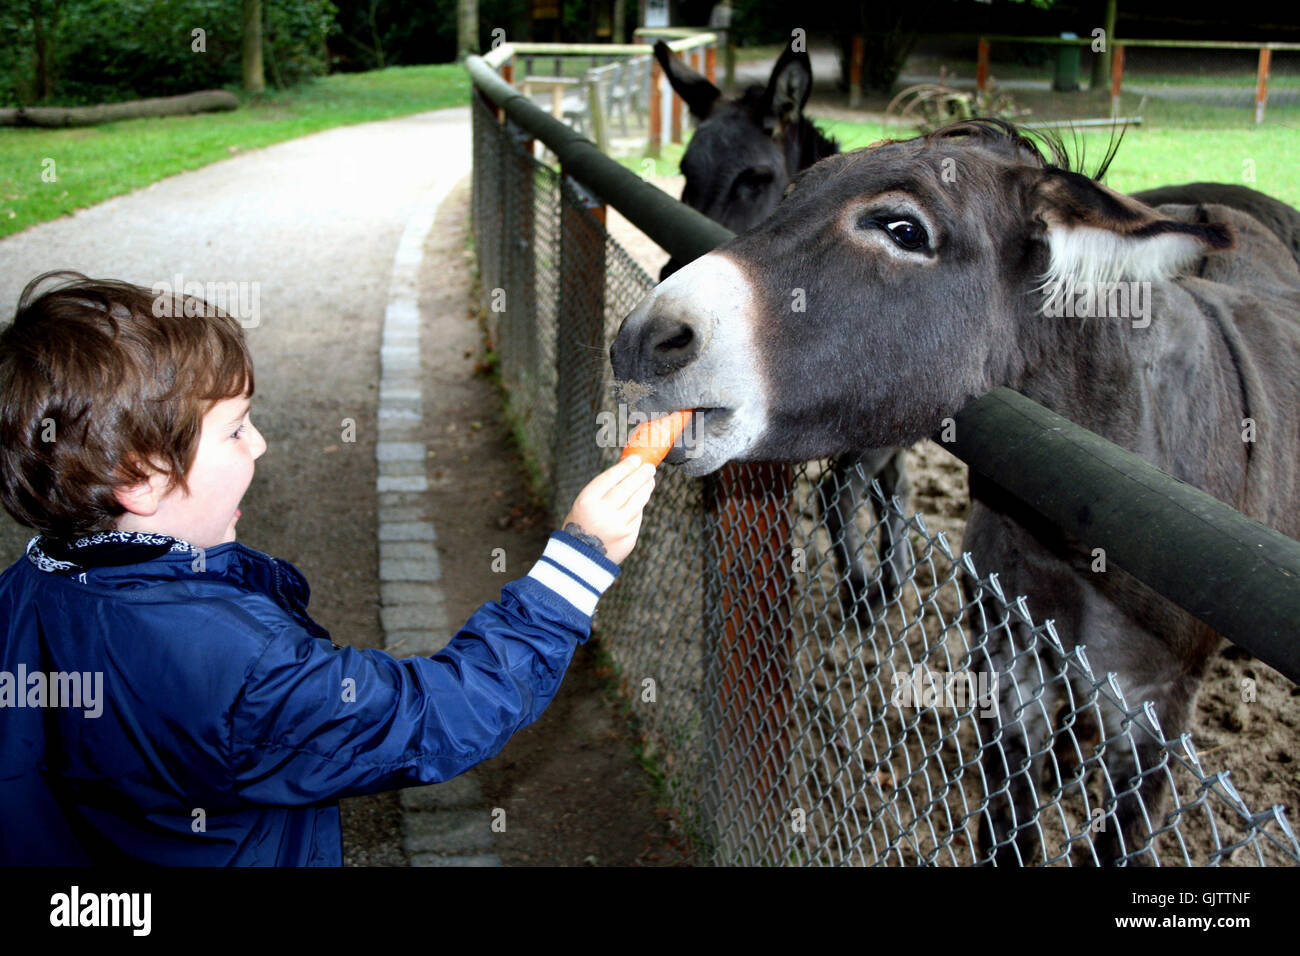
[703,463,794,865]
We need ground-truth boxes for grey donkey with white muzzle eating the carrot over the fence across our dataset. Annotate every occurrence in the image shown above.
[610,120,1300,865]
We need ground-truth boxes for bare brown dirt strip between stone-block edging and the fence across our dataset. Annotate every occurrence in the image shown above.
[403,182,688,866]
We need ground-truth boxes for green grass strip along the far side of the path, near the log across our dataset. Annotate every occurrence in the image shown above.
[0,64,469,237]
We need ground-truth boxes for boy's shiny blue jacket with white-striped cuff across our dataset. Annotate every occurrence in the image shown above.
[0,531,619,866]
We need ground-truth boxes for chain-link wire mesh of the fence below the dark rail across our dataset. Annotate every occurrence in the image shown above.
[473,96,1300,866]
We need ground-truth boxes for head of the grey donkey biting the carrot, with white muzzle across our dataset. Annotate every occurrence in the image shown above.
[610,121,1231,476]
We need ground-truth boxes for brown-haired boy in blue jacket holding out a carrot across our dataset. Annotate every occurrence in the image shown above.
[0,273,654,866]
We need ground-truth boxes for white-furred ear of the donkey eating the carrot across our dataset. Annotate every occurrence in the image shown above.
[1023,168,1232,286]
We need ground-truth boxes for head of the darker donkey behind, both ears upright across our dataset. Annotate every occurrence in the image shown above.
[654,40,839,278]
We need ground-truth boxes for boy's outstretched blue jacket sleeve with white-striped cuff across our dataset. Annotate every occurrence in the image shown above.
[229,531,619,805]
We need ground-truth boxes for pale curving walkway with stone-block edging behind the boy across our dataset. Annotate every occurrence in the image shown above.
[0,108,498,865]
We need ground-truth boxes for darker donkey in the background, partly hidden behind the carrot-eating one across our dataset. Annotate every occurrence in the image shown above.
[654,40,909,613]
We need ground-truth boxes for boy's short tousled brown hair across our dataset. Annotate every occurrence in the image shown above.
[0,272,254,537]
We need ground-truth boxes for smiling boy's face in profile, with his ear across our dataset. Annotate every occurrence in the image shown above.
[117,397,267,548]
